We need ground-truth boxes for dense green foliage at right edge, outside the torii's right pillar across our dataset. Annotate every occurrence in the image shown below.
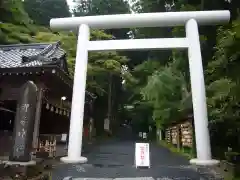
[206,21,240,150]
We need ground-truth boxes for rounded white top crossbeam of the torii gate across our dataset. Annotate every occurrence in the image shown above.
[50,11,230,30]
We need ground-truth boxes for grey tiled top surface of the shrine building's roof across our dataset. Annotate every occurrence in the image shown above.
[0,42,65,68]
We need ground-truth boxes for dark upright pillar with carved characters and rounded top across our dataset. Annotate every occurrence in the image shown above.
[9,81,37,162]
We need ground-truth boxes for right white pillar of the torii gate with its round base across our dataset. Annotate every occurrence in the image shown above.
[186,19,219,165]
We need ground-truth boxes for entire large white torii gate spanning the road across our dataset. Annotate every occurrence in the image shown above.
[50,11,230,165]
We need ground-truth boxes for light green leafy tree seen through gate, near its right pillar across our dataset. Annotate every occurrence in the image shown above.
[141,64,189,126]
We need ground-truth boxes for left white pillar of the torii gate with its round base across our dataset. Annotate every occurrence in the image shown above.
[61,24,90,163]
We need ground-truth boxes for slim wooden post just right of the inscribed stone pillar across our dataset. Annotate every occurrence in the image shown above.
[33,86,44,149]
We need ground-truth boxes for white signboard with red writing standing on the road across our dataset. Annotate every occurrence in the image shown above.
[135,143,150,168]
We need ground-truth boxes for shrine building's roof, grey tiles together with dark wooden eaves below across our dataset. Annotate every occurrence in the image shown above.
[0,42,95,98]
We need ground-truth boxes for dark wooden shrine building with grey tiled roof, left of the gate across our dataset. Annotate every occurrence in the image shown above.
[0,42,94,156]
